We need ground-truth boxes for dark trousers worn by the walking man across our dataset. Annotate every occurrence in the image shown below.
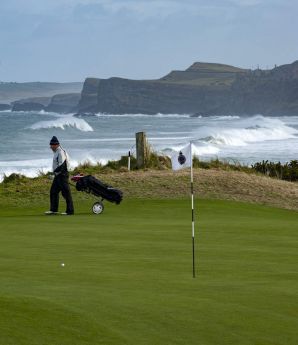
[50,175,74,214]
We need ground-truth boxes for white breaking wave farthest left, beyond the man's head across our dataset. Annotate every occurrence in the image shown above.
[28,114,93,132]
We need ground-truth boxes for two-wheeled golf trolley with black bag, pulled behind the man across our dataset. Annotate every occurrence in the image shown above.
[71,174,123,214]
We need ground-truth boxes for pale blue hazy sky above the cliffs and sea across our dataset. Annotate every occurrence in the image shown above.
[0,0,298,82]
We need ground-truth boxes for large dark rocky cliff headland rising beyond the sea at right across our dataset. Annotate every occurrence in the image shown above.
[79,61,298,115]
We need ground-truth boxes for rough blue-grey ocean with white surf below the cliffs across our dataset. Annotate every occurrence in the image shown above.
[0,111,298,180]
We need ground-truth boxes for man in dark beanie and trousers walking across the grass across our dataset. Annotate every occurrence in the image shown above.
[45,136,74,215]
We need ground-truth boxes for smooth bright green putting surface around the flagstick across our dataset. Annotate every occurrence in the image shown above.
[0,199,298,345]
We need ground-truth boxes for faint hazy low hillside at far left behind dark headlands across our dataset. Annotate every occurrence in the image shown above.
[0,82,83,103]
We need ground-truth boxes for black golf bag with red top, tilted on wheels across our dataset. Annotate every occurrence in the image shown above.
[73,175,123,205]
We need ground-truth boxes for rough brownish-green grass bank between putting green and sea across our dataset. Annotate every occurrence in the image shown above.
[0,169,298,210]
